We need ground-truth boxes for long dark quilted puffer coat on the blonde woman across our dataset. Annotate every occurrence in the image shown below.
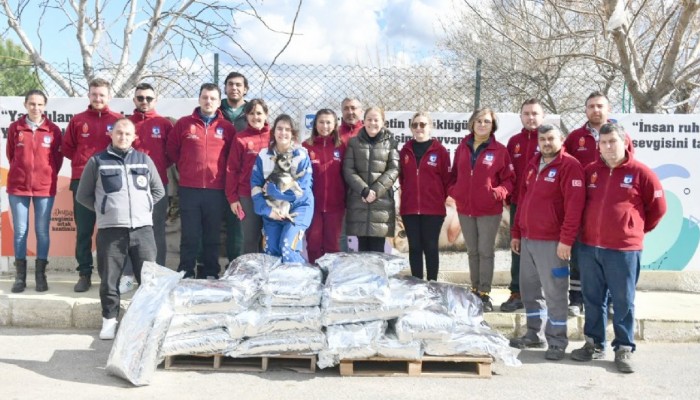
[343,128,399,237]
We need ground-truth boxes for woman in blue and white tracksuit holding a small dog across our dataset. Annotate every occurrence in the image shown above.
[250,114,314,262]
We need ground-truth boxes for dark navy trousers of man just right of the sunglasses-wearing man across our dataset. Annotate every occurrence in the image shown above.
[177,186,225,277]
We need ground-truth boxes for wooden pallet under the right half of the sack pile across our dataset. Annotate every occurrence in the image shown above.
[340,356,493,378]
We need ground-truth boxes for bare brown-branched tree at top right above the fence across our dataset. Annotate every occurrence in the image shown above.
[444,0,700,113]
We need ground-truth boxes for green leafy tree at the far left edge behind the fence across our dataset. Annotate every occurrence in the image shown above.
[0,40,41,96]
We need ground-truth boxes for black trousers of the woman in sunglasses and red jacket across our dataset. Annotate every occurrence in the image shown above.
[401,214,445,281]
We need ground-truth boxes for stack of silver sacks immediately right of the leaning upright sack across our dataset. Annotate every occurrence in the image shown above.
[161,254,278,356]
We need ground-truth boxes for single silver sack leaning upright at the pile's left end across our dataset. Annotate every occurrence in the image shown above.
[107,262,182,386]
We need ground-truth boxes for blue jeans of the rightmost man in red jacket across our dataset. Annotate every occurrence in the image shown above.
[578,243,642,351]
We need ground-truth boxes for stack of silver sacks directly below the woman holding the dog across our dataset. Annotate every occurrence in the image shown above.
[225,262,326,357]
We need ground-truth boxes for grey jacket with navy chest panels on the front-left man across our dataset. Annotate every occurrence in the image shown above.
[75,145,165,229]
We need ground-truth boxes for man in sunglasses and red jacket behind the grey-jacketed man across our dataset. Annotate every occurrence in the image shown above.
[129,83,173,270]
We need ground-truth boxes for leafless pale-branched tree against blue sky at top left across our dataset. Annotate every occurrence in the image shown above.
[0,0,302,96]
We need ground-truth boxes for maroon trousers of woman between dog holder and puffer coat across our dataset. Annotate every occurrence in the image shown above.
[306,210,347,264]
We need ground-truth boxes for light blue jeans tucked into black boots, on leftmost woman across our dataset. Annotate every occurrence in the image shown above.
[7,194,54,260]
